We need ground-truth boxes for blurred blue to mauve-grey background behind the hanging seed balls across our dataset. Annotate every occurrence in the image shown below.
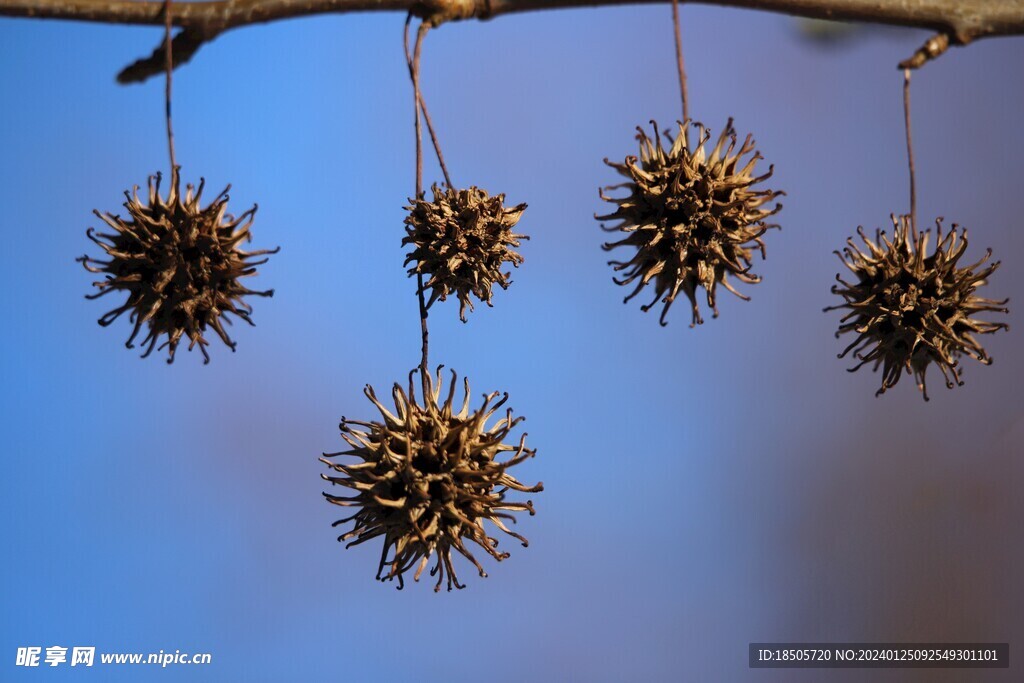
[0,5,1024,682]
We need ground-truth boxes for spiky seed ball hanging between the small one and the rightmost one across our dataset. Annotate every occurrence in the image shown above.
[595,119,784,327]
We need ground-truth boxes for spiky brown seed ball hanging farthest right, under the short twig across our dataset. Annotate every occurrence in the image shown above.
[825,215,1009,400]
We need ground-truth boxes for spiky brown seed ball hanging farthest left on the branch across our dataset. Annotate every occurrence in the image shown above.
[77,167,278,362]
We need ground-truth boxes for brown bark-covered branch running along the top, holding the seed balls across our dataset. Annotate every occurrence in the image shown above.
[0,0,1024,82]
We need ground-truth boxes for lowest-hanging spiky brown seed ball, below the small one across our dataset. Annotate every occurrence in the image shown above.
[321,367,544,591]
